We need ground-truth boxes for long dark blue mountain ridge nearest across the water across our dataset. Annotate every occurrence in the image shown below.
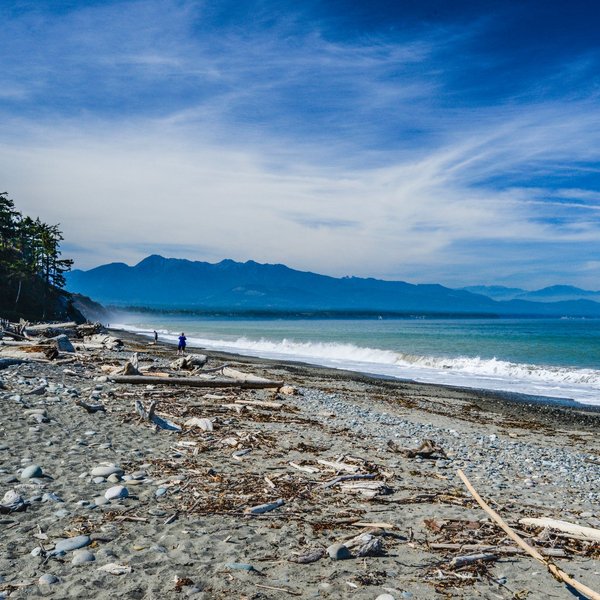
[67,255,600,316]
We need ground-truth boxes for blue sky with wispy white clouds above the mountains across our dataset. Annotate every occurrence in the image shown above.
[0,0,600,289]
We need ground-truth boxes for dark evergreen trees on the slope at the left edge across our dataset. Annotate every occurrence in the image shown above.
[0,192,78,320]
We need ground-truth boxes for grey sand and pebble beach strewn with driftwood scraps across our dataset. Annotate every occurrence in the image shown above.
[0,331,600,600]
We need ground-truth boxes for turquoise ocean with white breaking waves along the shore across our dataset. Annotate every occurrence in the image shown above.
[111,313,600,406]
